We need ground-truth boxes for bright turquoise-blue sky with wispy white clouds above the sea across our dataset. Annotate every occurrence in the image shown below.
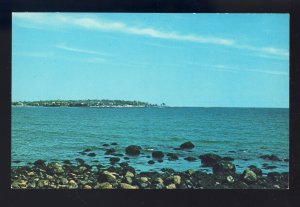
[12,13,289,108]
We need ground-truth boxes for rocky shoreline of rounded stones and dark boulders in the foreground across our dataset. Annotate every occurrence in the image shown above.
[11,142,289,189]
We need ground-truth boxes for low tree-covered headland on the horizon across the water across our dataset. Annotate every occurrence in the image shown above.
[12,99,167,108]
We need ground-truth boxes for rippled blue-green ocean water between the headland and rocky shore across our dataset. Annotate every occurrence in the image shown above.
[12,107,289,173]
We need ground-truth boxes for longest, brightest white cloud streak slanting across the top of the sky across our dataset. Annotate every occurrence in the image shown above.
[13,13,289,60]
